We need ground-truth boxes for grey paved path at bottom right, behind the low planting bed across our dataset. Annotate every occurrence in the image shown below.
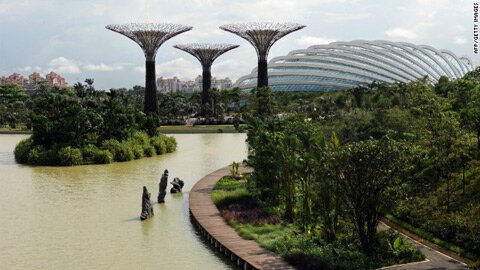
[379,223,469,270]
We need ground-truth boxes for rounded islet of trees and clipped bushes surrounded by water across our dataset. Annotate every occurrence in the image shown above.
[15,80,176,166]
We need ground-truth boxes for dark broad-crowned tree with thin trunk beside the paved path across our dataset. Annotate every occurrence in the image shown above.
[331,138,408,255]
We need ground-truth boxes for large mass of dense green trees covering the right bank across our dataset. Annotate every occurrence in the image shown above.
[247,70,480,268]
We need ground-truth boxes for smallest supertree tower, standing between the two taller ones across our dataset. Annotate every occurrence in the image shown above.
[173,43,238,116]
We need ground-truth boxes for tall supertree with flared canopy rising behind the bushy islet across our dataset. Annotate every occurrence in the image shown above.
[106,23,192,114]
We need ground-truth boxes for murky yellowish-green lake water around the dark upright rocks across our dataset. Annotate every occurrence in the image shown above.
[0,134,247,270]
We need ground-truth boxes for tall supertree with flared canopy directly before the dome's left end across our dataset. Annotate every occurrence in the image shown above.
[220,22,305,87]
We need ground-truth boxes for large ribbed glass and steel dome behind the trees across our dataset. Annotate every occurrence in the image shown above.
[235,40,474,91]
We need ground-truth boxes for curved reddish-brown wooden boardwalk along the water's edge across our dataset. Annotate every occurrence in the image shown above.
[189,166,295,269]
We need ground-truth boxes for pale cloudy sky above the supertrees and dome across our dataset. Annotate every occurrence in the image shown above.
[0,0,474,90]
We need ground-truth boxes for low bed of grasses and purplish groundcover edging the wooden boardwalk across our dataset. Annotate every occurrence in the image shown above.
[212,177,424,270]
